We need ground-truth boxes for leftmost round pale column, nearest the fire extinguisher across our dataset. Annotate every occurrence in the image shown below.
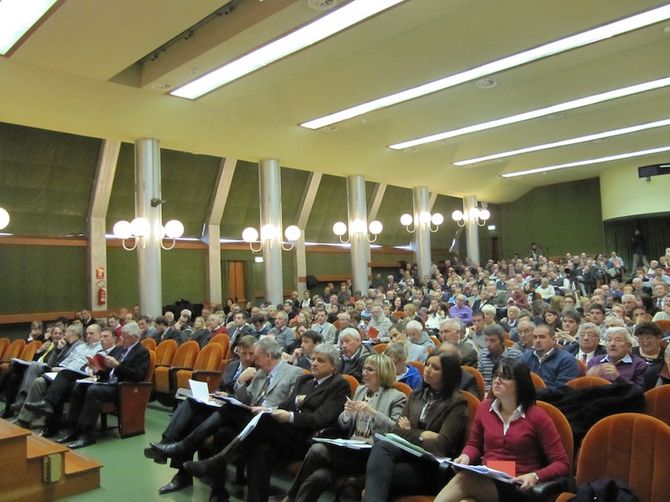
[135,138,163,316]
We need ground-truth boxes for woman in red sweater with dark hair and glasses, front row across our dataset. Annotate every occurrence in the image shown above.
[435,359,570,502]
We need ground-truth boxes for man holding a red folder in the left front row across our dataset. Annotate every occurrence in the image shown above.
[25,328,123,436]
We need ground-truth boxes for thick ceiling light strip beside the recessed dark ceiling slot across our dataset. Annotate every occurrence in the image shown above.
[170,0,404,99]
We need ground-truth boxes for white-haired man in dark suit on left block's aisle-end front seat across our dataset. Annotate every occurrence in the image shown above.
[67,321,150,449]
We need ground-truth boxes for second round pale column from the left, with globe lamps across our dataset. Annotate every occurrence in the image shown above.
[258,159,284,305]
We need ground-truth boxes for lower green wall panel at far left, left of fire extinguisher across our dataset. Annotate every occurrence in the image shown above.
[0,246,86,314]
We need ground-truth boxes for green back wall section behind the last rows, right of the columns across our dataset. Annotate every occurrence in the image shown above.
[500,178,604,257]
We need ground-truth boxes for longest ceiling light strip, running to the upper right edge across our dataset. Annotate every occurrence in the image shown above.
[300,5,670,129]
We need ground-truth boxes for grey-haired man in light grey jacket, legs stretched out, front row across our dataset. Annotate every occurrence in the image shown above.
[145,337,304,494]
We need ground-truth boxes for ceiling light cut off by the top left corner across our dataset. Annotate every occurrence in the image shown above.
[0,0,56,56]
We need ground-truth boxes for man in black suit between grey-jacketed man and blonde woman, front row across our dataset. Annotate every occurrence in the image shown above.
[184,344,349,502]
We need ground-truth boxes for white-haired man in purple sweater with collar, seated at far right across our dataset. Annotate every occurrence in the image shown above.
[586,327,647,389]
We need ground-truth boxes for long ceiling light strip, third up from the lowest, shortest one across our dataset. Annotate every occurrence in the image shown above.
[389,77,670,150]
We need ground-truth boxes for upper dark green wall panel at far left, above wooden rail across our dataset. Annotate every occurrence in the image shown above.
[0,123,101,235]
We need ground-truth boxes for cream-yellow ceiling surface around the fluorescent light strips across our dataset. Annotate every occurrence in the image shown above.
[0,0,670,202]
